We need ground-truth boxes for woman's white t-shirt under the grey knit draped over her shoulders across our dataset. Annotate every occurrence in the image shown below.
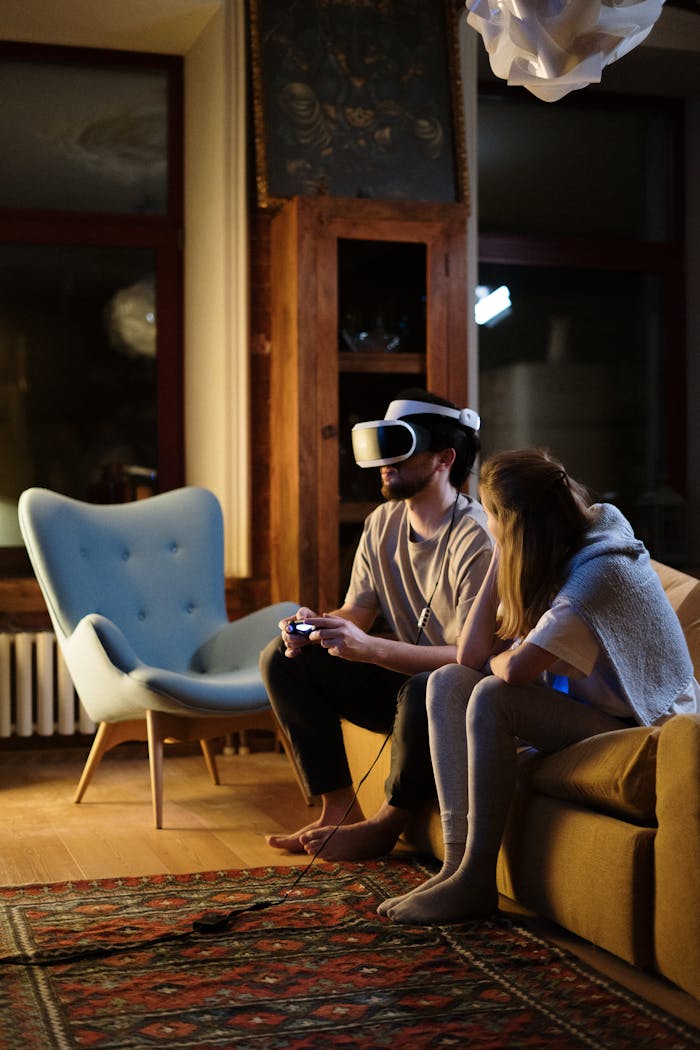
[523,599,700,723]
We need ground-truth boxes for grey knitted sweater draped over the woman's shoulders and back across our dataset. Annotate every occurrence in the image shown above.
[557,503,693,726]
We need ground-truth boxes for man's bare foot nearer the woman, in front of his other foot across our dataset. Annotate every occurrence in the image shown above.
[300,802,408,860]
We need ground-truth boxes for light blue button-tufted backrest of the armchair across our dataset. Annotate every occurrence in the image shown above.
[19,487,227,671]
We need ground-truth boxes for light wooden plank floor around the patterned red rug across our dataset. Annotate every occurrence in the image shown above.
[0,741,700,1028]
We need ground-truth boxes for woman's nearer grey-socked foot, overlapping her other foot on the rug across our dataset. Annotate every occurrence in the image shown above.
[388,870,499,925]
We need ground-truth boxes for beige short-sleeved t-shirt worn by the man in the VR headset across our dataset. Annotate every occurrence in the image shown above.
[345,494,492,646]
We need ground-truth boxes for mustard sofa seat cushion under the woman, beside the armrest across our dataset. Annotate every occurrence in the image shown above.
[522,727,659,826]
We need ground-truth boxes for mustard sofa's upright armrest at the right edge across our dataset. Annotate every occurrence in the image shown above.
[654,714,700,999]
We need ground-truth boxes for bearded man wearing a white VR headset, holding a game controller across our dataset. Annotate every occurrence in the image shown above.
[260,389,491,860]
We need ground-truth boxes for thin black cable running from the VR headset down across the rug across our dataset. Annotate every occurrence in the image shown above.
[0,491,460,966]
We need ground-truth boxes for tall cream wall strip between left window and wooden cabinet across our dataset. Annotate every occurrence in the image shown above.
[185,0,251,576]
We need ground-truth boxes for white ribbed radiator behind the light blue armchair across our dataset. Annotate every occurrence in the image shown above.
[0,631,94,737]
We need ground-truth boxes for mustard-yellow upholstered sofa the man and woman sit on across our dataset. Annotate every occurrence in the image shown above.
[344,563,700,999]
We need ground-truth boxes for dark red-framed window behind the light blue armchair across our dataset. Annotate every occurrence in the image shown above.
[0,44,183,574]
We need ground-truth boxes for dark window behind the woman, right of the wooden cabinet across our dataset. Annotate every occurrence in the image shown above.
[479,92,685,565]
